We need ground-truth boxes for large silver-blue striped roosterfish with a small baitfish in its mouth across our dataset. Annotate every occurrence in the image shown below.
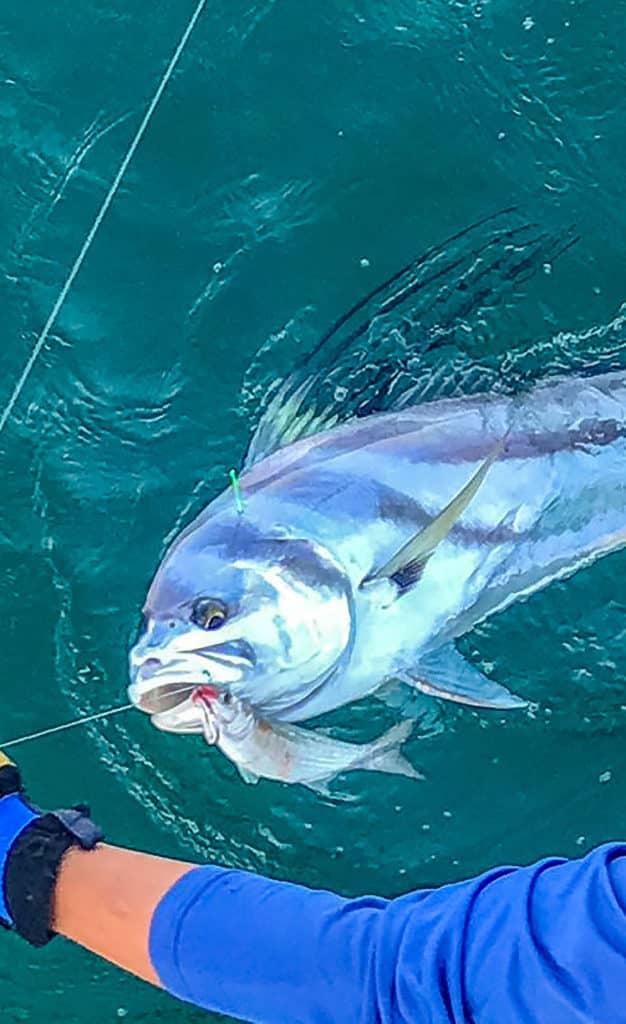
[129,214,626,784]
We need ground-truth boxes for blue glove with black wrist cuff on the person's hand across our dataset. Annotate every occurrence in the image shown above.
[0,751,103,946]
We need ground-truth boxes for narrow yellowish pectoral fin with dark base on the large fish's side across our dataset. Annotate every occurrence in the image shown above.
[362,439,506,593]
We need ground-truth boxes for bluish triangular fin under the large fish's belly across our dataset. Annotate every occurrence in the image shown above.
[404,645,528,711]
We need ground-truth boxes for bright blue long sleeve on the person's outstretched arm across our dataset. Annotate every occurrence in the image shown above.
[151,844,626,1024]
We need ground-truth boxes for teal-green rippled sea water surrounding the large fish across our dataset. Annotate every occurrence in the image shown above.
[0,0,626,1024]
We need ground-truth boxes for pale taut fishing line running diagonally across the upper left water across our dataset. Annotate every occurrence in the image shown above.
[0,0,207,433]
